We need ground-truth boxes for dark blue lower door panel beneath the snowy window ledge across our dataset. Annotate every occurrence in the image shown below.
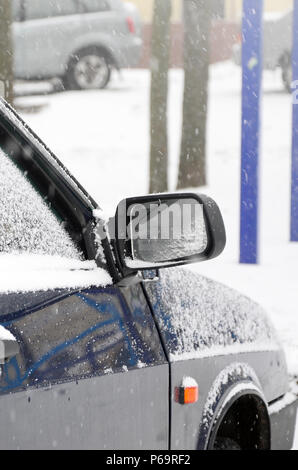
[0,286,169,449]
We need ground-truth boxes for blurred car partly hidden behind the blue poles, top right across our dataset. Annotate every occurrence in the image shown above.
[233,10,293,92]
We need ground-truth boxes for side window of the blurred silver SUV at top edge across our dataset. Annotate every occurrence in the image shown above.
[25,0,77,20]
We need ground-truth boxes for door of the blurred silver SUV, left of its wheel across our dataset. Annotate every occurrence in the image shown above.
[15,0,81,79]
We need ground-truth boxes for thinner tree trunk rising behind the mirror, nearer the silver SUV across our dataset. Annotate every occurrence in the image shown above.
[149,0,171,193]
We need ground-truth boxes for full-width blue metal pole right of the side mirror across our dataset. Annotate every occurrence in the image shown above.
[240,0,263,264]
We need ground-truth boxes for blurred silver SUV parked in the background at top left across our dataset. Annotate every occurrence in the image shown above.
[13,0,142,90]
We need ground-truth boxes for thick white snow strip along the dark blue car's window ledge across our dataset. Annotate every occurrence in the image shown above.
[0,254,112,293]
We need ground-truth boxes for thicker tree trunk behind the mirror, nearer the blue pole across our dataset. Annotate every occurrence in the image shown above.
[177,0,211,189]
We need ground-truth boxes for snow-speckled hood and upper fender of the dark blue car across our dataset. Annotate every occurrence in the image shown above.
[145,269,281,361]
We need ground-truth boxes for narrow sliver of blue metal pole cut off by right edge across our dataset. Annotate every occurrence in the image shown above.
[291,0,298,242]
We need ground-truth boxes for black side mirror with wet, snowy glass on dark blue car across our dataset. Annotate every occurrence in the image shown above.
[114,193,226,274]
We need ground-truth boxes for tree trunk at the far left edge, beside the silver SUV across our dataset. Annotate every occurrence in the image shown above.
[0,0,13,104]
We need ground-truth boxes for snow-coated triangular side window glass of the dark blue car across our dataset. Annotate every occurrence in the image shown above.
[0,149,80,259]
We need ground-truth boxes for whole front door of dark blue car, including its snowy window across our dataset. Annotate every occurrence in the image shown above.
[0,104,169,449]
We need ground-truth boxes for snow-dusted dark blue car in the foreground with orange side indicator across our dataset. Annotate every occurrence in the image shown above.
[0,96,297,450]
